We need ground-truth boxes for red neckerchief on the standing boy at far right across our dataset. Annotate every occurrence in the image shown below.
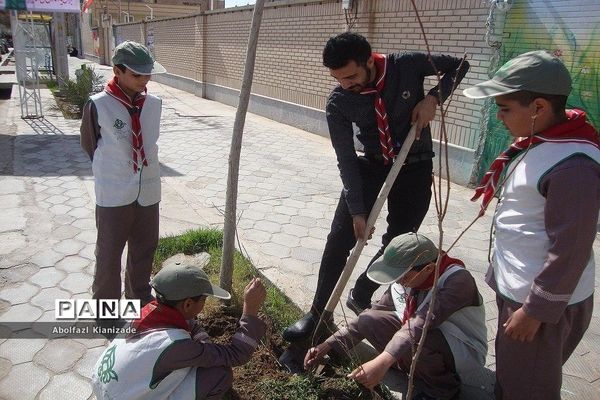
[471,110,600,216]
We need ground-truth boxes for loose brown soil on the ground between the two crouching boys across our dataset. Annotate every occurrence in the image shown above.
[200,308,389,400]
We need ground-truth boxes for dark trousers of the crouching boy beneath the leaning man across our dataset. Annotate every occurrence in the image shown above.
[358,310,460,399]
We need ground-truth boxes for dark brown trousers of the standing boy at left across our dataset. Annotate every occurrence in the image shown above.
[92,202,159,305]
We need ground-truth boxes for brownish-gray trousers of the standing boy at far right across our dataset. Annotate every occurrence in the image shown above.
[494,296,594,400]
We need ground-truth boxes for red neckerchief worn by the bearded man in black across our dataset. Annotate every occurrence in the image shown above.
[360,53,396,165]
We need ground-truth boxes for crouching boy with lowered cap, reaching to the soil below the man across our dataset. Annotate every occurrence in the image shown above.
[304,233,487,400]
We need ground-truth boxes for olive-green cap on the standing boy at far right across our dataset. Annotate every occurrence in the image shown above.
[463,50,571,99]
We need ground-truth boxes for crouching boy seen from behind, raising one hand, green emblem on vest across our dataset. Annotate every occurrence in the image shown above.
[92,263,266,400]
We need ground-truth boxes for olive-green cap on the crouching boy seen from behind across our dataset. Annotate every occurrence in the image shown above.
[150,262,231,301]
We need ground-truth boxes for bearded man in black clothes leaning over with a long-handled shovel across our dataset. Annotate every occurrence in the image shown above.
[283,32,469,341]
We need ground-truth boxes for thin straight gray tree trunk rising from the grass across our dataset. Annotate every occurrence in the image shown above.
[219,0,265,290]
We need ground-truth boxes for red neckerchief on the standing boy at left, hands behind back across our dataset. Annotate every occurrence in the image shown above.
[104,76,148,173]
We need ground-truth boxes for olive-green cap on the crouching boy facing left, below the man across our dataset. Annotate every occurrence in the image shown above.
[367,232,438,285]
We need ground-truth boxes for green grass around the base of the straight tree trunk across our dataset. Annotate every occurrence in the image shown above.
[154,229,302,331]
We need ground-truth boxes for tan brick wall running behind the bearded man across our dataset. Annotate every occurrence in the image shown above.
[108,0,491,148]
